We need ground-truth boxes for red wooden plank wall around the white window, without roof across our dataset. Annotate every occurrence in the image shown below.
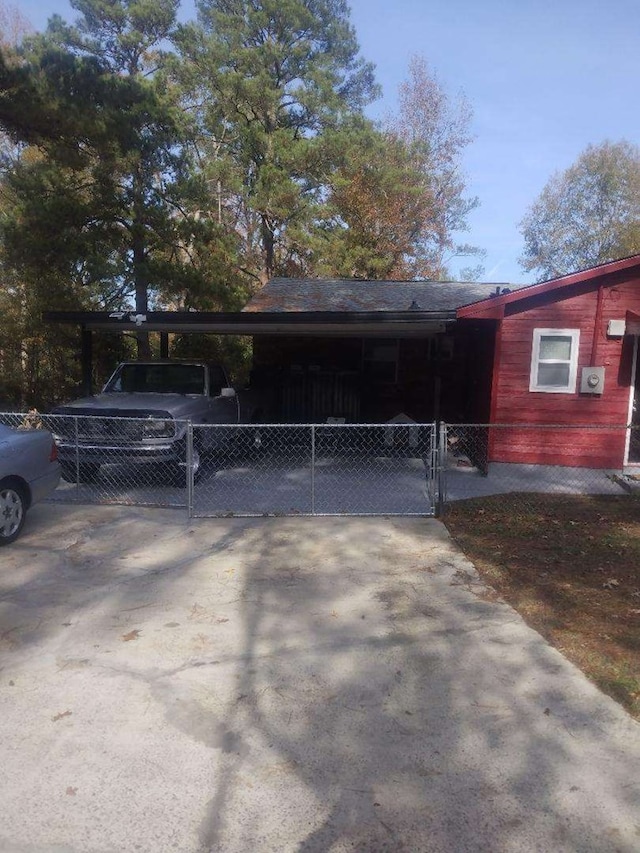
[489,279,640,468]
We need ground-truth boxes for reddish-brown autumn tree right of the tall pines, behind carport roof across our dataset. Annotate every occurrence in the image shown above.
[313,59,483,279]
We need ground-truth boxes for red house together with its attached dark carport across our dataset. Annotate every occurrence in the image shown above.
[45,255,640,472]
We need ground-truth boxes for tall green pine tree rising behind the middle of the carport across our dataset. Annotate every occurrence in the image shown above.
[179,0,377,283]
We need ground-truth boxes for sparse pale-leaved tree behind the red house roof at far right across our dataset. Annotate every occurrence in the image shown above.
[520,141,640,281]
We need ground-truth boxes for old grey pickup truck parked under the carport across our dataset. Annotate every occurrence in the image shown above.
[51,360,256,485]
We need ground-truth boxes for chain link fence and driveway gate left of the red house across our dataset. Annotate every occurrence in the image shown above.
[0,412,436,516]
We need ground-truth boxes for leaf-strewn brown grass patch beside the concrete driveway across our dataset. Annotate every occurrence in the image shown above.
[443,494,640,720]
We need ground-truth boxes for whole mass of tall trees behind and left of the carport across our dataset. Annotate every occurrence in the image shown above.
[0,0,476,401]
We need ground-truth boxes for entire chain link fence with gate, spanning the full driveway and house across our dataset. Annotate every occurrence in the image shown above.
[5,412,640,516]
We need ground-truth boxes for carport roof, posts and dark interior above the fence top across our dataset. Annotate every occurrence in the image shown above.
[43,279,501,423]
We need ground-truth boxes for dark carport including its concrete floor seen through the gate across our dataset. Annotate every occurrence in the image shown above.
[45,279,499,516]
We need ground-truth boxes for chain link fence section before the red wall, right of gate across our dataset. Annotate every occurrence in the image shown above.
[438,424,640,513]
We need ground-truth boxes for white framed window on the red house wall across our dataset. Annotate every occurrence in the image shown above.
[529,329,580,394]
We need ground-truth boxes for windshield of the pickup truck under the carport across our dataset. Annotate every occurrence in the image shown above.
[104,364,205,394]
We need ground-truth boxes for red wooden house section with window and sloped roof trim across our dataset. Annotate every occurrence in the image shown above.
[457,256,640,469]
